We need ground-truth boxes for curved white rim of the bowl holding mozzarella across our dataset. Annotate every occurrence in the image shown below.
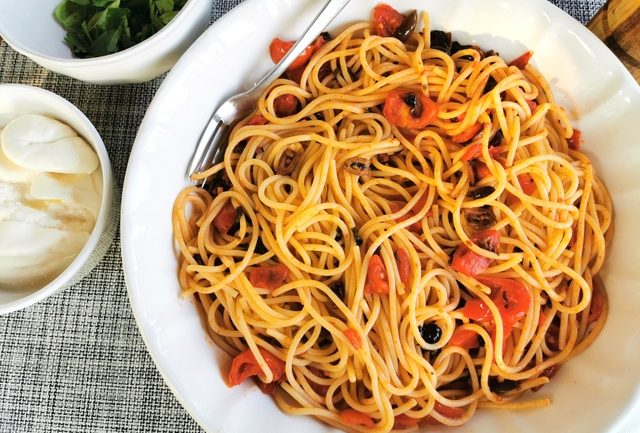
[0,84,113,315]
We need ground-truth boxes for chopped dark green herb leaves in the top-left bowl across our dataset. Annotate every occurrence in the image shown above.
[55,0,187,58]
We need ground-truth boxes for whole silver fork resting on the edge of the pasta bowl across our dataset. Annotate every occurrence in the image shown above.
[186,0,350,188]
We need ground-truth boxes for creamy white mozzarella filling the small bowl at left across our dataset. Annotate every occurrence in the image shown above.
[0,114,102,288]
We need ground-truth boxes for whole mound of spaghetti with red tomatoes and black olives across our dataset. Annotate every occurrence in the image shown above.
[173,5,613,432]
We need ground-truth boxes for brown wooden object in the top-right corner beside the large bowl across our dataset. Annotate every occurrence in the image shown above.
[587,0,640,82]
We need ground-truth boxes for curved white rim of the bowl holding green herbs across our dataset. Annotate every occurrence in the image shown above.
[0,0,204,68]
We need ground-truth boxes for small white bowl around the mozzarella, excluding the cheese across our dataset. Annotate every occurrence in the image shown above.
[0,84,118,314]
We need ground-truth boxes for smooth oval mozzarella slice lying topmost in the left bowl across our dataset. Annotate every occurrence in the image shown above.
[0,114,99,174]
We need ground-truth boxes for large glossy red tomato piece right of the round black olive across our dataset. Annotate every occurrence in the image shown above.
[477,277,531,324]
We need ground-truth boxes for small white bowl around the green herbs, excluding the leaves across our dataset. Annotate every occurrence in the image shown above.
[0,0,213,84]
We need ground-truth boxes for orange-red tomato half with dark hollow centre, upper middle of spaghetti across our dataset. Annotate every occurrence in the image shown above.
[382,89,440,129]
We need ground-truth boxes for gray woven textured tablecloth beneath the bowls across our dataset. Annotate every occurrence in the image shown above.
[0,0,604,433]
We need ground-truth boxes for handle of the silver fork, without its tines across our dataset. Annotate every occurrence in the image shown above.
[216,0,351,120]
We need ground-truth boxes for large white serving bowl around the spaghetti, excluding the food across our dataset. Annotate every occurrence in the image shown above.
[121,0,640,433]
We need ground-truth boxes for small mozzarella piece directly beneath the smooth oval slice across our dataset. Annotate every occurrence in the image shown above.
[29,173,101,219]
